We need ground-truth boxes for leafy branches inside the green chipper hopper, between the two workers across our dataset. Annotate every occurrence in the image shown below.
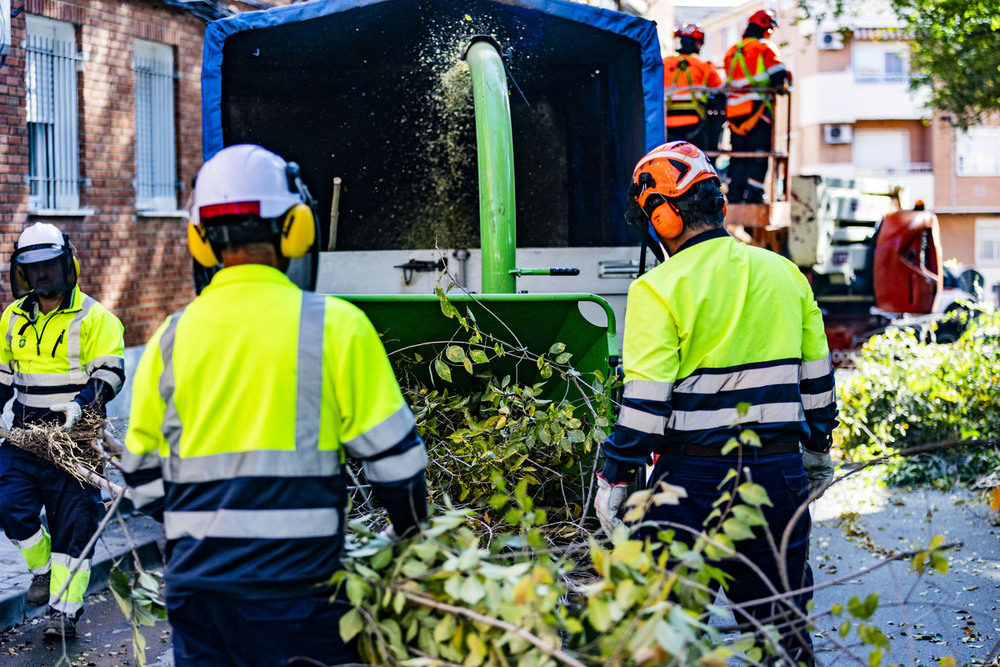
[362,289,620,539]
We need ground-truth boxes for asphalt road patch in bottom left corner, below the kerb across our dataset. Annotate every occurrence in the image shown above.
[0,592,174,667]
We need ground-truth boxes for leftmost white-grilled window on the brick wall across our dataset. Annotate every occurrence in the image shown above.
[25,15,80,210]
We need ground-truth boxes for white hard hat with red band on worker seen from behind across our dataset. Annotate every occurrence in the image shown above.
[190,144,305,225]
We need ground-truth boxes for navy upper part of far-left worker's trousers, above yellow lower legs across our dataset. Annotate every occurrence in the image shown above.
[0,444,101,558]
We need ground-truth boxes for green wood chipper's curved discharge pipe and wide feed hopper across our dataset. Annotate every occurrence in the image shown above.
[339,36,618,398]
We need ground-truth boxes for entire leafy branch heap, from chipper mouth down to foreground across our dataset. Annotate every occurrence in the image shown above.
[335,293,945,667]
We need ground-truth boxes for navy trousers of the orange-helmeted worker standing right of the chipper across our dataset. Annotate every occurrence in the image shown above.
[640,448,813,665]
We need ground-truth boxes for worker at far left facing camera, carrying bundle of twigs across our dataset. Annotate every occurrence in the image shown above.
[0,222,125,639]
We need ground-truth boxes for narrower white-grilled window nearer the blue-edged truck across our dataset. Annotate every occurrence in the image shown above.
[133,39,177,211]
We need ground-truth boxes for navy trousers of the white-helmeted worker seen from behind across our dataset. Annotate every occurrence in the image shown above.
[167,582,360,667]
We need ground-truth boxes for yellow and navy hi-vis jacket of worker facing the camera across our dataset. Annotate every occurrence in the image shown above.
[0,286,125,426]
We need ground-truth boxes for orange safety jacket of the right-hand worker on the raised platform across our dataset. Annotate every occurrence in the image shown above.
[725,37,786,134]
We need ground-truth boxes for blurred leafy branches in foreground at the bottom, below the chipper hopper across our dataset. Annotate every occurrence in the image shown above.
[334,464,954,667]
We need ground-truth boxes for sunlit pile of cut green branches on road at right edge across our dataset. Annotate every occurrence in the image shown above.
[834,306,1000,486]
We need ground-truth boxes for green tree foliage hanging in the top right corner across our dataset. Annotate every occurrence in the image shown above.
[799,0,1000,129]
